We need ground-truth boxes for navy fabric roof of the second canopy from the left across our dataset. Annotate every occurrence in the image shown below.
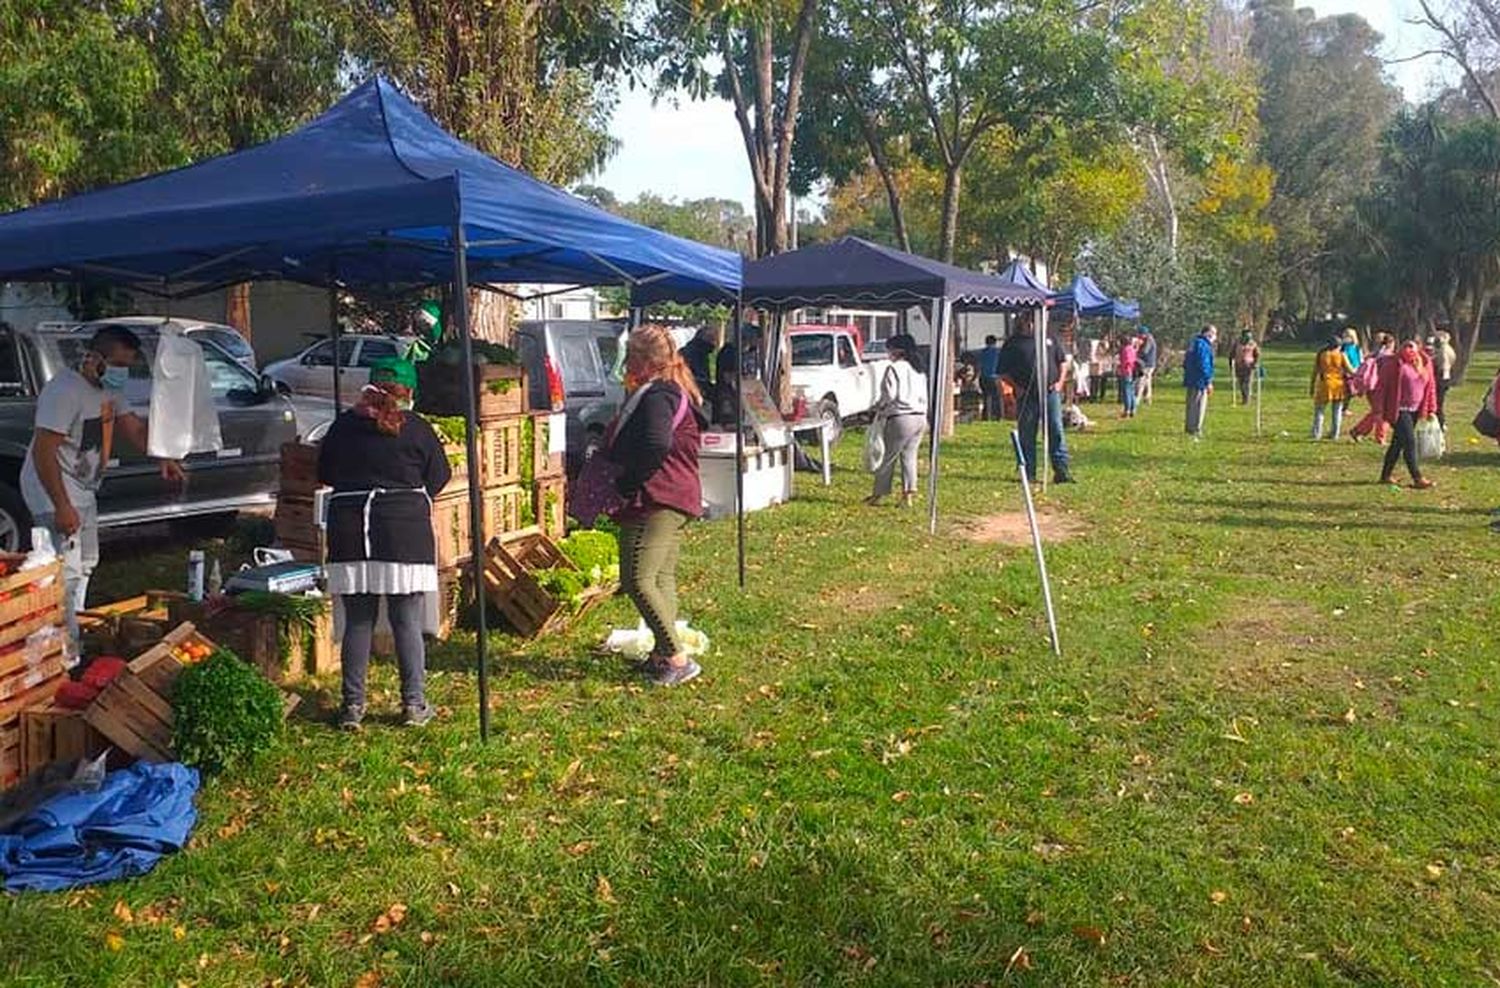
[633,237,1047,309]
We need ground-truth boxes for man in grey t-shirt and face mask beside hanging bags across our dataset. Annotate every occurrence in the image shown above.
[21,325,185,640]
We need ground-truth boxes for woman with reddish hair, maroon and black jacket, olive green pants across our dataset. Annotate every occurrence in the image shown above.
[606,325,708,687]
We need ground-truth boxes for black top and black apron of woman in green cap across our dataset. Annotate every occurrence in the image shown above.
[318,411,453,564]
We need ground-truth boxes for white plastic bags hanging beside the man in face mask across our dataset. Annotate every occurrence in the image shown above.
[146,325,224,460]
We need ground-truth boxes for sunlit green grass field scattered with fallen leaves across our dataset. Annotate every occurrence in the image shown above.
[0,351,1500,987]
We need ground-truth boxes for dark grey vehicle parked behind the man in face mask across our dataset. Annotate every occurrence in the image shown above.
[0,328,333,550]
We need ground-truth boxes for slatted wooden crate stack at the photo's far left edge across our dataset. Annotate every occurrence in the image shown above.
[0,553,69,789]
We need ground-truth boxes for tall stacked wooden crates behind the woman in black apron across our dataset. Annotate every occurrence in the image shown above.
[276,366,567,602]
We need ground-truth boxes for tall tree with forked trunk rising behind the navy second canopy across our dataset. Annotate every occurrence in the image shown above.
[650,0,818,256]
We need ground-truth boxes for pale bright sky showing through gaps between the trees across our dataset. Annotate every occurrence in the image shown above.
[593,0,1442,210]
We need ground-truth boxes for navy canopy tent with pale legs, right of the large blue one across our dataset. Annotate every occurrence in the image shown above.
[632,237,1047,533]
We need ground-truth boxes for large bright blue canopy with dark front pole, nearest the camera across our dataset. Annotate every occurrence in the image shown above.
[0,78,741,736]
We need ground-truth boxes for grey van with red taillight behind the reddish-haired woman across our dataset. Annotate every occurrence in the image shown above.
[516,319,626,466]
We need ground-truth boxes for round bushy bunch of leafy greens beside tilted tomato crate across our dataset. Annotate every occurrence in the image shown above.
[173,649,284,774]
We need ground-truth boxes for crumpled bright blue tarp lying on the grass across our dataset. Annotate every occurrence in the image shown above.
[0,762,198,892]
